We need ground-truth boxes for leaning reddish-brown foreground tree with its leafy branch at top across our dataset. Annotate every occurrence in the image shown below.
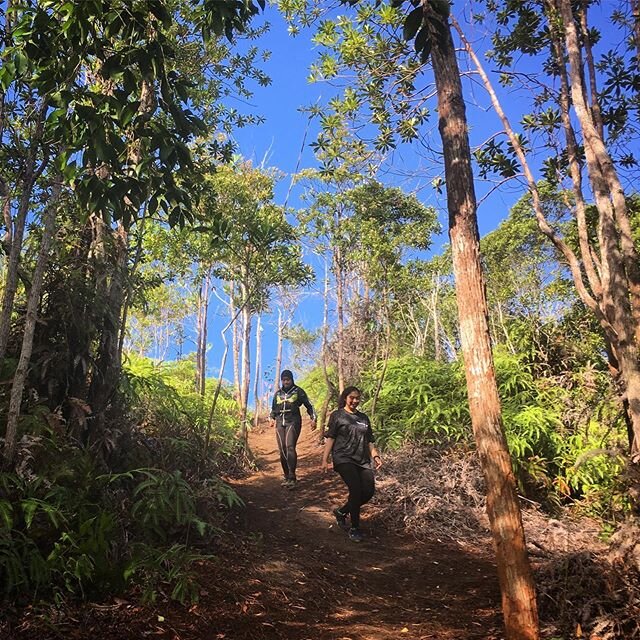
[284,0,538,640]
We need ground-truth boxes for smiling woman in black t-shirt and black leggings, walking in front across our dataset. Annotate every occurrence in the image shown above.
[322,387,382,542]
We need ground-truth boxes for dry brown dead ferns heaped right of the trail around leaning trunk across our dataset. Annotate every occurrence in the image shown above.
[375,447,640,640]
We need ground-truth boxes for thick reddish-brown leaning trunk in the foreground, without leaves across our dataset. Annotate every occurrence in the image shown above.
[423,2,539,640]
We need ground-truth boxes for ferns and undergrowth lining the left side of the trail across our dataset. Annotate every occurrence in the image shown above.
[0,358,241,601]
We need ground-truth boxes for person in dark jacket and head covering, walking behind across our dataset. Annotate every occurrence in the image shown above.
[271,369,316,489]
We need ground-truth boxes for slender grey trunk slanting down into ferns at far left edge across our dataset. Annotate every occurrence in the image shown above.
[3,183,62,468]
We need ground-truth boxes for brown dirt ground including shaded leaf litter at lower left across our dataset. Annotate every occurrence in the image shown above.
[0,425,503,640]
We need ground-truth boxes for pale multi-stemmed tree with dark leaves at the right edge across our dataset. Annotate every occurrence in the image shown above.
[466,0,640,460]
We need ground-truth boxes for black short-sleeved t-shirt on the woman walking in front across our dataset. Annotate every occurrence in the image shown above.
[325,409,376,467]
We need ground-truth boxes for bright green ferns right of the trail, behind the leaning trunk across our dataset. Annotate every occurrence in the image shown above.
[362,349,630,519]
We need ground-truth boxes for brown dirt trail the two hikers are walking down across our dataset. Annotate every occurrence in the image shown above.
[213,424,502,640]
